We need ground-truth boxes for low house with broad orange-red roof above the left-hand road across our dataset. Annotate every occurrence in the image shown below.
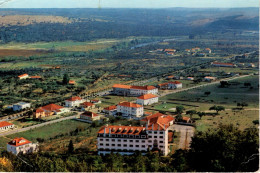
[33,104,68,118]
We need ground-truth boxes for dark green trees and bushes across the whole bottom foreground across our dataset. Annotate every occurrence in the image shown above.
[0,125,259,172]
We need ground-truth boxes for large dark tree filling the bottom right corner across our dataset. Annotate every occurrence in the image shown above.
[187,125,259,172]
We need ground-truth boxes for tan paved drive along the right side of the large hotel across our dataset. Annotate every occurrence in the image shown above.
[169,124,195,149]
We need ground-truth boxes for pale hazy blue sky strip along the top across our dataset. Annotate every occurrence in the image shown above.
[0,0,259,8]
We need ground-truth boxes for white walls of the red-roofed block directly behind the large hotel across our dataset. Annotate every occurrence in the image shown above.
[116,104,144,117]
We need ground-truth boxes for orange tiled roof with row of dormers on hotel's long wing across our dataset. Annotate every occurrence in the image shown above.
[98,125,145,135]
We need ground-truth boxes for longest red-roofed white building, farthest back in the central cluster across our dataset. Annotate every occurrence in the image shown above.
[113,84,158,96]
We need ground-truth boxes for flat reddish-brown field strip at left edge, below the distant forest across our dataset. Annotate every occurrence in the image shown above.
[0,49,47,57]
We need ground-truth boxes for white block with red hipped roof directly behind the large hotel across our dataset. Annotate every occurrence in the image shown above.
[117,102,144,117]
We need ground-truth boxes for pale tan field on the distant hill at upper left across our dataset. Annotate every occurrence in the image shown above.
[0,15,72,26]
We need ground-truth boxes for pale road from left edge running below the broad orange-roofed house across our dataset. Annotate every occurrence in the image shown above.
[0,112,81,136]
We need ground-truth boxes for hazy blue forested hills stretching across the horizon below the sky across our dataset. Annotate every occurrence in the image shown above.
[0,8,259,43]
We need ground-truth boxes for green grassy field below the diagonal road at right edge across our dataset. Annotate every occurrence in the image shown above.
[160,76,259,111]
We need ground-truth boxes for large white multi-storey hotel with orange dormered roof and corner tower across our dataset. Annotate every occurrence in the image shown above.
[97,113,174,155]
